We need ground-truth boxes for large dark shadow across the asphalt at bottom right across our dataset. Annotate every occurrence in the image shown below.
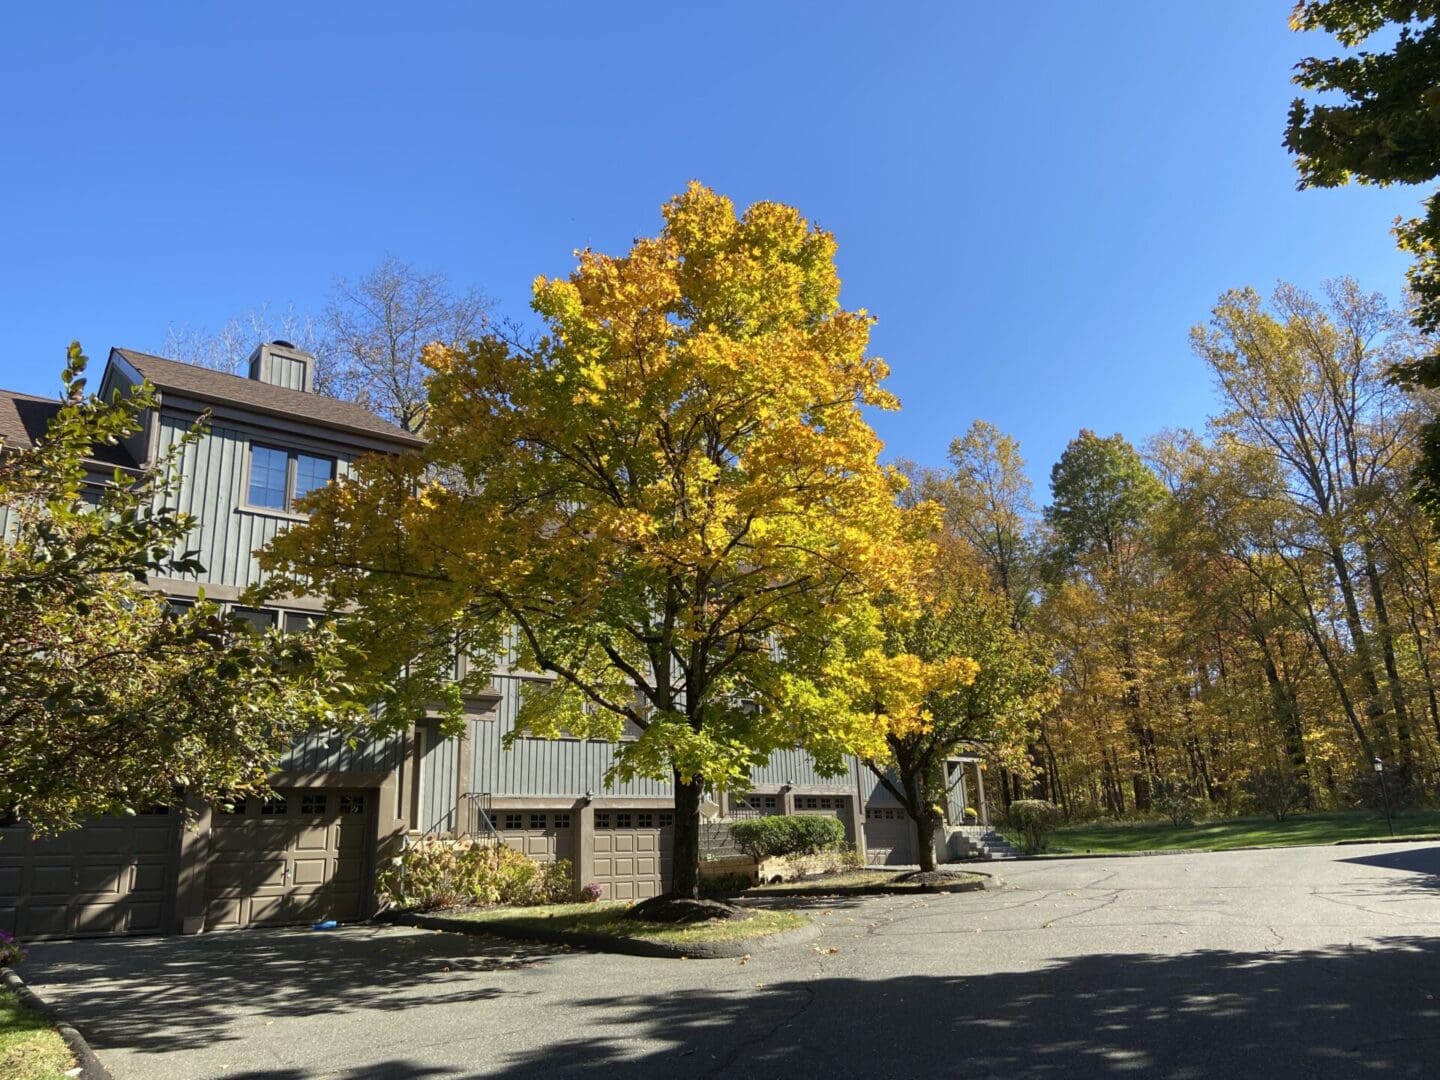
[477,937,1440,1080]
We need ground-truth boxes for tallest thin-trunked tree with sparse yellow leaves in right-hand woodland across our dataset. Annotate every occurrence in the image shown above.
[1192,281,1418,789]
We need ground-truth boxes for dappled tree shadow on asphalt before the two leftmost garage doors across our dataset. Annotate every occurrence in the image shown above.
[22,927,559,1059]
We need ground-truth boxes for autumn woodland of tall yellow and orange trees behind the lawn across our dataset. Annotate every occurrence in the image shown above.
[913,279,1440,818]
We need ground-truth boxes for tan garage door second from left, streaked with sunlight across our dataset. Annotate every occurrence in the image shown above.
[204,789,374,930]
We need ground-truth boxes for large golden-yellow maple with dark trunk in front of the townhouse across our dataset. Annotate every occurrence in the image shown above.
[264,183,912,897]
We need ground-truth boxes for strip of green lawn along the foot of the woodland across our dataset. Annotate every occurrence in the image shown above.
[1047,809,1440,855]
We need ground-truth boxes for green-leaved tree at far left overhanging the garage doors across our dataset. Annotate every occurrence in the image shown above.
[0,344,346,831]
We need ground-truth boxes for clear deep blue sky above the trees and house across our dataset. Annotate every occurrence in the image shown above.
[0,0,1418,494]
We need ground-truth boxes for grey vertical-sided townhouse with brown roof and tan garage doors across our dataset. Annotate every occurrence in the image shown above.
[0,341,984,939]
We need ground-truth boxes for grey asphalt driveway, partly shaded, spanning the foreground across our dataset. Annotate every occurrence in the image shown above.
[23,842,1440,1080]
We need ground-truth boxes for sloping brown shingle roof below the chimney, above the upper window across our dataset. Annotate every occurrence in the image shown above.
[112,348,425,446]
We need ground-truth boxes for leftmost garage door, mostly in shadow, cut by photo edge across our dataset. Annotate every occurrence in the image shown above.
[0,808,180,940]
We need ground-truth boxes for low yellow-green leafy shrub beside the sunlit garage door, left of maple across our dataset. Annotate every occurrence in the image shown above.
[376,837,575,912]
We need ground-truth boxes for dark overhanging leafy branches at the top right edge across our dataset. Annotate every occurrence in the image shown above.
[1284,0,1440,516]
